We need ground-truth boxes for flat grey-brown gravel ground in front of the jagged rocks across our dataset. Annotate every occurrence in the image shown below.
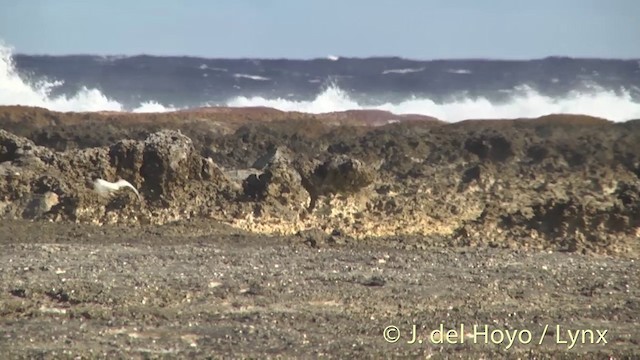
[0,220,640,359]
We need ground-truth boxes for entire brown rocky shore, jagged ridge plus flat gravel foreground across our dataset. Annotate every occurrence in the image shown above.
[0,107,640,359]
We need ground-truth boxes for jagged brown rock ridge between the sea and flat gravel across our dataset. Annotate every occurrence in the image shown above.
[0,107,640,255]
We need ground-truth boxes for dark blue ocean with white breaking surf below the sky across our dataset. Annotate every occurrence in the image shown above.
[0,45,640,121]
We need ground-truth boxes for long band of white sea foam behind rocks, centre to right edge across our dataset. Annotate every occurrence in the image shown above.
[227,86,640,121]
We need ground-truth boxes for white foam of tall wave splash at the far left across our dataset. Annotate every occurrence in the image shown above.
[0,42,172,112]
